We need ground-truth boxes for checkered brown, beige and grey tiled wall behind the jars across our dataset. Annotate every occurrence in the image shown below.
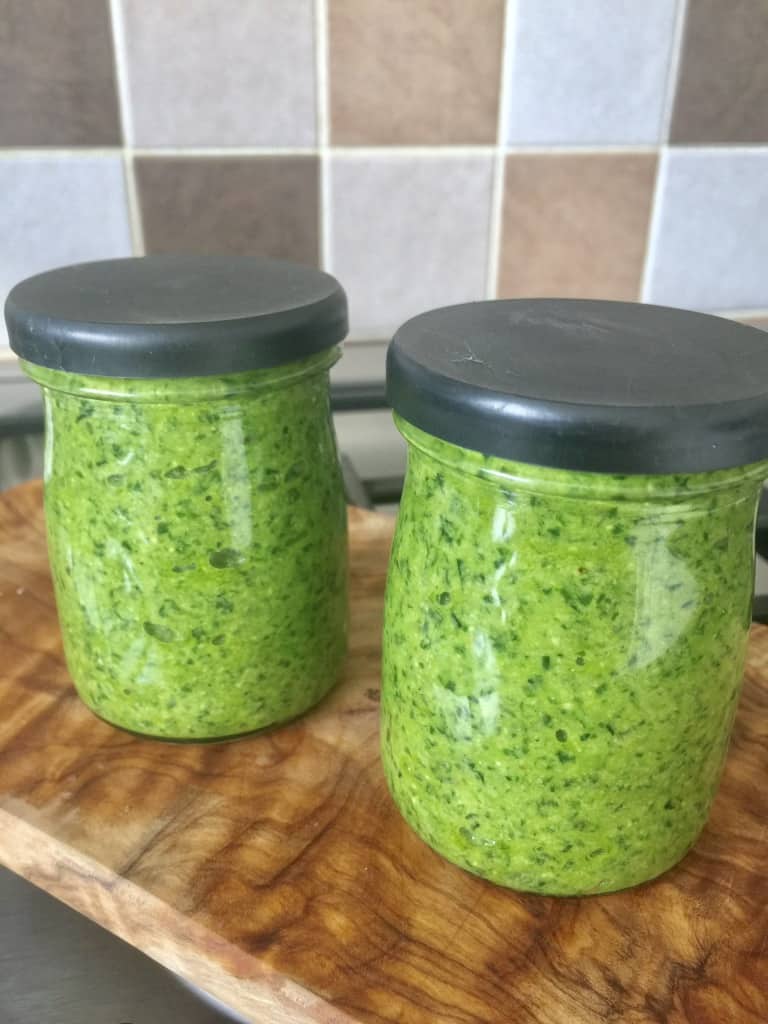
[0,0,768,368]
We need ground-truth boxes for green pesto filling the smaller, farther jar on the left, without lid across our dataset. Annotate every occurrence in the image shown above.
[25,349,346,739]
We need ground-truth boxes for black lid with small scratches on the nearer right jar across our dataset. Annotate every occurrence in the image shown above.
[387,299,768,473]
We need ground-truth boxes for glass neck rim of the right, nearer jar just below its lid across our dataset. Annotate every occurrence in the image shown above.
[394,414,768,505]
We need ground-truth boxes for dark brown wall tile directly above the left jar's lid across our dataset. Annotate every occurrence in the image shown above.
[136,156,318,264]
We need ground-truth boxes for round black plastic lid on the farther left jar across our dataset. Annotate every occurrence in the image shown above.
[5,256,347,378]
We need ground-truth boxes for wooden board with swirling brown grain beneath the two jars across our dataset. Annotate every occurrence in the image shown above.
[0,484,768,1024]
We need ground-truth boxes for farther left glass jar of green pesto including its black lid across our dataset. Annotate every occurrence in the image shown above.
[6,256,347,740]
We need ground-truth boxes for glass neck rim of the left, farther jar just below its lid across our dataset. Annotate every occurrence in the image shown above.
[22,345,341,403]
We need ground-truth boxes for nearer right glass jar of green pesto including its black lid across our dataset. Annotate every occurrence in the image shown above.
[382,299,768,895]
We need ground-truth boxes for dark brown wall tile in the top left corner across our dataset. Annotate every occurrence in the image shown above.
[0,0,120,146]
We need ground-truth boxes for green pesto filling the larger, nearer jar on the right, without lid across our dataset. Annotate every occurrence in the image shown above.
[382,420,768,895]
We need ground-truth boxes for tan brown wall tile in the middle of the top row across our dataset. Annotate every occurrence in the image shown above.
[329,0,504,145]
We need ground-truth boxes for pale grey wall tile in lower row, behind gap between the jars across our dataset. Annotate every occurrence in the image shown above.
[329,152,493,340]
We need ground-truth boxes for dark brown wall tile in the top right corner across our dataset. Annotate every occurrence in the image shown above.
[671,0,768,142]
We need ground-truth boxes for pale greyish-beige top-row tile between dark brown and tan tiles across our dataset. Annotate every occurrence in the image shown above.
[122,0,315,146]
